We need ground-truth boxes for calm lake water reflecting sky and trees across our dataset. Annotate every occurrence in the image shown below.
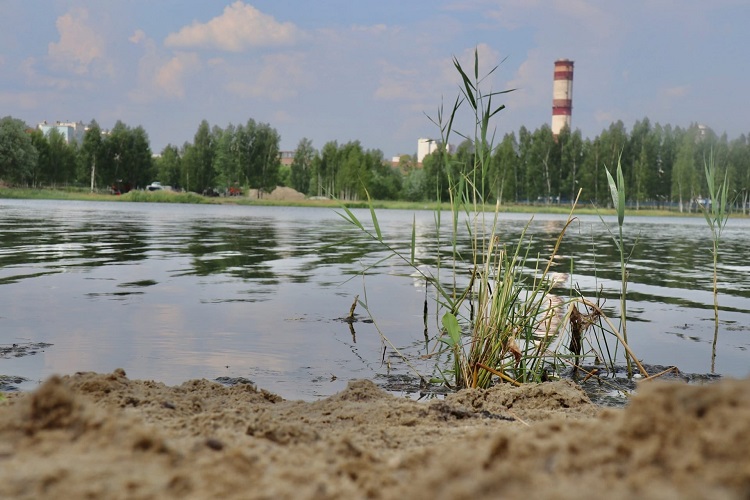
[0,200,750,400]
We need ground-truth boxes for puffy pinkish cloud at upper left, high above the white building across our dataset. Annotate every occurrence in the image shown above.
[48,9,112,75]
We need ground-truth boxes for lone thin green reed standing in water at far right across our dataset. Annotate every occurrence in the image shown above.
[701,151,729,372]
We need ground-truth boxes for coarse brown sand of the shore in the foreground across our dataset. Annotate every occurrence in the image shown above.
[0,370,750,499]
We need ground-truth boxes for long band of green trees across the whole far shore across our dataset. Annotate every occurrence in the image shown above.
[0,117,750,212]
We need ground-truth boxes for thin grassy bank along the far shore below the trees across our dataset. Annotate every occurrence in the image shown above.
[0,187,742,217]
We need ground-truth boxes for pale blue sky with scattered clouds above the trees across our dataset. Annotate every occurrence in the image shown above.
[0,0,750,158]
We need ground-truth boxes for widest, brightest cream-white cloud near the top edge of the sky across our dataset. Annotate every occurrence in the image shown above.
[164,1,300,52]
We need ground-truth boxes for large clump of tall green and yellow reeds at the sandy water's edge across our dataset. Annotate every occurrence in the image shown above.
[339,47,640,388]
